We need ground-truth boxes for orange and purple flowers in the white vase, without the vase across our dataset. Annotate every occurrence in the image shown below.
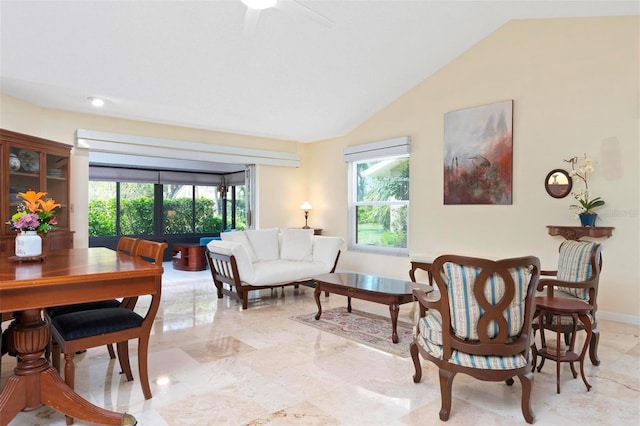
[7,190,60,234]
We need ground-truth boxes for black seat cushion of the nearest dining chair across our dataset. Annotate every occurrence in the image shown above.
[51,308,143,340]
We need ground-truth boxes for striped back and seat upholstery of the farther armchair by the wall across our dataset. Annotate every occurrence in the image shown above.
[557,240,597,301]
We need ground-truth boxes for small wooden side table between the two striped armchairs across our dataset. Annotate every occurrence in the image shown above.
[533,297,593,393]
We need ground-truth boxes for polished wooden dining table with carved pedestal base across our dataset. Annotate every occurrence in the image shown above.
[0,247,163,426]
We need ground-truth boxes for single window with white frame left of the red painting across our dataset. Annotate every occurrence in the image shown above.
[349,155,409,254]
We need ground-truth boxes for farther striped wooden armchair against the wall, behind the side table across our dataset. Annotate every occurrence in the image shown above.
[533,240,602,365]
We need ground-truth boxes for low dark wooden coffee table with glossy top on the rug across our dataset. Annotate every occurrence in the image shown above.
[313,272,433,343]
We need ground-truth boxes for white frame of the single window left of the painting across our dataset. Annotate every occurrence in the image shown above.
[347,154,410,256]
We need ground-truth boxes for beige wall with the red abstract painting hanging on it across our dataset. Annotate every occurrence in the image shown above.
[309,17,640,322]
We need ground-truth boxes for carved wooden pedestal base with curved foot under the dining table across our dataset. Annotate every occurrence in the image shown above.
[0,309,136,426]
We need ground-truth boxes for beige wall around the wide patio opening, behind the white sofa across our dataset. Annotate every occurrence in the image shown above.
[0,95,306,247]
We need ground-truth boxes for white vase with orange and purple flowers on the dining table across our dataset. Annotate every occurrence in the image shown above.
[7,190,60,257]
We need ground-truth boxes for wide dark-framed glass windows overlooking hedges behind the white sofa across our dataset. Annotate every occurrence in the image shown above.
[88,166,249,247]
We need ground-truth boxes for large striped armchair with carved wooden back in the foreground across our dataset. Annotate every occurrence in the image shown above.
[411,255,540,423]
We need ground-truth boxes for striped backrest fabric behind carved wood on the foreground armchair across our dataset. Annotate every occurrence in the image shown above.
[444,262,530,340]
